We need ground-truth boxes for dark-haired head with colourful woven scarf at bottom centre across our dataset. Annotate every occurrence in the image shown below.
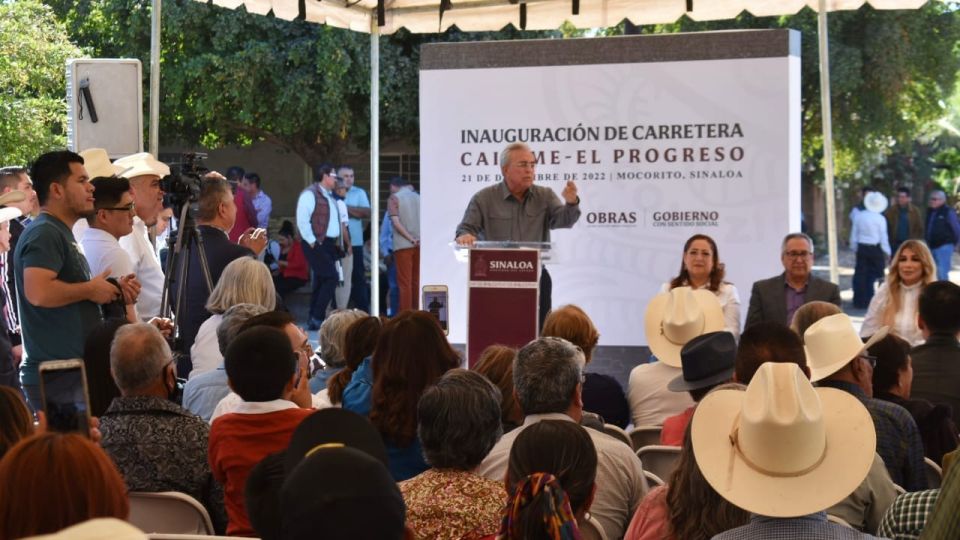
[489,420,598,540]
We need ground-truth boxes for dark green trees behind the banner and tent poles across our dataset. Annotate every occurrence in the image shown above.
[16,0,960,192]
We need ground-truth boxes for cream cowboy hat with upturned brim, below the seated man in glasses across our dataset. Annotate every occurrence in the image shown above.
[803,313,889,382]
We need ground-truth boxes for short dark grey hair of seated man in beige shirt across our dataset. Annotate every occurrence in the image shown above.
[513,337,586,415]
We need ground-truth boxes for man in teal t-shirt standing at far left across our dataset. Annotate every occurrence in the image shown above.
[14,151,139,410]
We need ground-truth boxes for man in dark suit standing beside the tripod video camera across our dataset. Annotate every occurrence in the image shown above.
[170,173,267,376]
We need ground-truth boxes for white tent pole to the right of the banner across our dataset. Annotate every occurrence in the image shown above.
[817,0,840,283]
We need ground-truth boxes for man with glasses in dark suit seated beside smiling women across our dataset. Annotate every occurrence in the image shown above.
[744,233,840,329]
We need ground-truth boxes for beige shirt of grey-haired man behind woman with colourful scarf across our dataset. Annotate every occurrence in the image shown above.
[475,413,648,538]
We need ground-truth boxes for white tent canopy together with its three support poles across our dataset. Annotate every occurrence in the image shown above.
[161,0,927,314]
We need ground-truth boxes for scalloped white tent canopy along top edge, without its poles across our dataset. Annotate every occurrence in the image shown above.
[201,0,926,34]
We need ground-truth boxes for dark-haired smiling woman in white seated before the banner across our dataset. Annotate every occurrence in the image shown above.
[660,234,740,341]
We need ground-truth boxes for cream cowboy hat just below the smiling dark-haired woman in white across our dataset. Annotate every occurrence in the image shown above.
[644,287,724,367]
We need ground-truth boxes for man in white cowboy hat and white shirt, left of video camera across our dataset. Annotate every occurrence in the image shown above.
[114,152,170,320]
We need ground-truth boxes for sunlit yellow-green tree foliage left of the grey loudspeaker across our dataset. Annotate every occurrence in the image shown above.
[0,0,82,165]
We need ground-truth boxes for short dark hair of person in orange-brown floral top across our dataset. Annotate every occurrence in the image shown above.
[417,369,503,471]
